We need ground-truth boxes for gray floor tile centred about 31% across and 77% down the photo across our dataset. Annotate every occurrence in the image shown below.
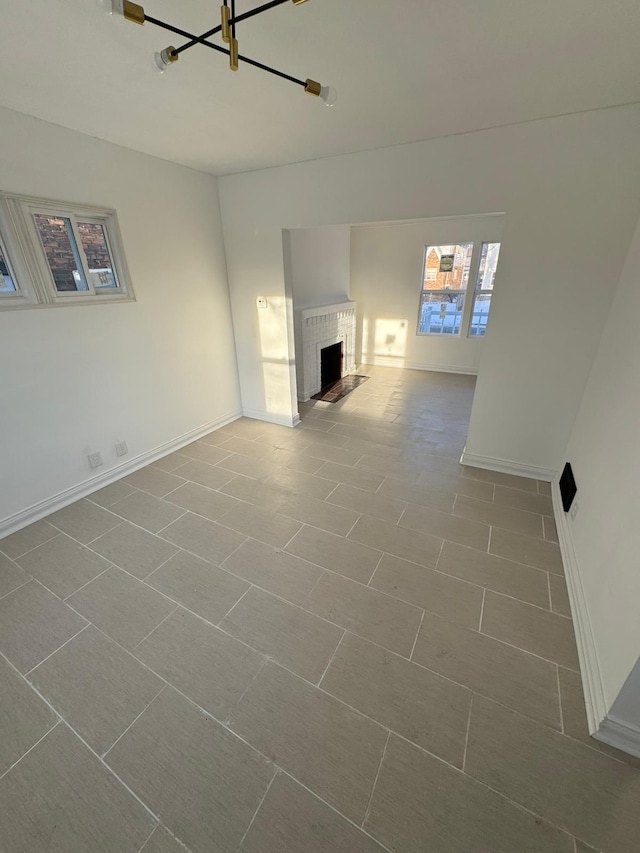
[135,608,263,720]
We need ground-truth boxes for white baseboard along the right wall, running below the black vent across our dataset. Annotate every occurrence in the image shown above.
[551,481,608,735]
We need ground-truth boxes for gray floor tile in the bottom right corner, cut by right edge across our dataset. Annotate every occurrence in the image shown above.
[465,698,640,853]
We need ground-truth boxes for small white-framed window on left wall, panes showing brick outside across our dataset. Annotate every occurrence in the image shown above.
[0,194,134,307]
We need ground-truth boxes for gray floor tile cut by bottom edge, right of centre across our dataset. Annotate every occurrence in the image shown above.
[364,735,573,853]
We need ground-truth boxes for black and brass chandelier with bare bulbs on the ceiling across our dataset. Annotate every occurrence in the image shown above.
[104,0,337,107]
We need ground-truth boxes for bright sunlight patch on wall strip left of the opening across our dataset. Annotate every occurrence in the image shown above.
[256,296,297,420]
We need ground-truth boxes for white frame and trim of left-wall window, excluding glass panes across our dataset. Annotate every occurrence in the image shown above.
[0,193,135,310]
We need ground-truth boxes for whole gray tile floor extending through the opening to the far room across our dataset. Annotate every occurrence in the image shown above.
[0,369,640,853]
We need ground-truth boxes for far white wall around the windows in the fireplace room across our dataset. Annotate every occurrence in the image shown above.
[351,216,503,373]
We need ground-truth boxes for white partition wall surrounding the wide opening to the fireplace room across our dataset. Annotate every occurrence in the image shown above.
[219,104,640,473]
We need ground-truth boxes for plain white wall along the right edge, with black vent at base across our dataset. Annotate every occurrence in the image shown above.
[565,216,640,730]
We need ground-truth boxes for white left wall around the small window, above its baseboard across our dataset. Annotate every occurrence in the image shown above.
[0,110,239,530]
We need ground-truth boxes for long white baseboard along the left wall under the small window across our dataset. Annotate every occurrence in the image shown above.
[0,410,242,539]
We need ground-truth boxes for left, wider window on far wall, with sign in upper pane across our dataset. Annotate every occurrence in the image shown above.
[418,243,473,335]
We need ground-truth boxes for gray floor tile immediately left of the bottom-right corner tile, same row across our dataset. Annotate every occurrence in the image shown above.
[320,634,471,767]
